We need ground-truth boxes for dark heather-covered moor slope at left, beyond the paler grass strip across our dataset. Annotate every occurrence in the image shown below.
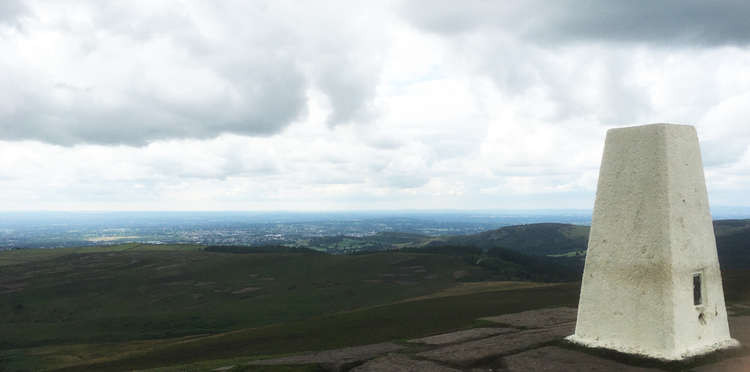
[0,251,506,349]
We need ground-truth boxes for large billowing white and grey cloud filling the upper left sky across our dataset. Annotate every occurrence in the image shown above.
[0,1,388,146]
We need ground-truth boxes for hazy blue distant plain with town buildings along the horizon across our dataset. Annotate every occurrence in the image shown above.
[0,208,750,250]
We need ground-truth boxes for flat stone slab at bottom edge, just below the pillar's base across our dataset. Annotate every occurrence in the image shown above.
[503,346,659,372]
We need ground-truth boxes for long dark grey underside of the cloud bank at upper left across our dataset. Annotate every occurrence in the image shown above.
[0,66,305,145]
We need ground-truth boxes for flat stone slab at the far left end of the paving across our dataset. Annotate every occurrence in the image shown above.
[249,342,404,370]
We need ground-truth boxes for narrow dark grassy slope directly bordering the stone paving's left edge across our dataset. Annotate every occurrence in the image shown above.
[50,284,578,371]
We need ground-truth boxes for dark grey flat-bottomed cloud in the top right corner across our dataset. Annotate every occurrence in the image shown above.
[404,0,750,45]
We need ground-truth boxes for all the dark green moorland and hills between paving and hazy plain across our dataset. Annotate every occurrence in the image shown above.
[0,221,750,371]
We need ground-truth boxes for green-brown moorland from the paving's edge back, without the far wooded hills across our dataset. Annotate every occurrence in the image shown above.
[0,244,575,370]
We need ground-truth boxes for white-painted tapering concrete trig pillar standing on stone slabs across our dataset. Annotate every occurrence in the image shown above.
[568,124,739,360]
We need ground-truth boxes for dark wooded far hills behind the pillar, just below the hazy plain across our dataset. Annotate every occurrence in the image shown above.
[286,220,750,272]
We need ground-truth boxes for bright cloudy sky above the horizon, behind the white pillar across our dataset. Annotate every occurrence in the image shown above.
[0,0,750,210]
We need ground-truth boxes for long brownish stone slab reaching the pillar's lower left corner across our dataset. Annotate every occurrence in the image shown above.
[417,324,573,367]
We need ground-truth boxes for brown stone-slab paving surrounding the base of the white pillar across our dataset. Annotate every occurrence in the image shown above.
[232,308,750,372]
